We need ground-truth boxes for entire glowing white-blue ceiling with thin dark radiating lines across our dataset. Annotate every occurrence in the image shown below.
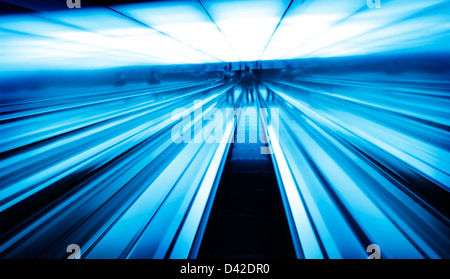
[0,0,450,71]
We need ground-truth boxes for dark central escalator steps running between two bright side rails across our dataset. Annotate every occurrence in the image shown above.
[197,90,296,259]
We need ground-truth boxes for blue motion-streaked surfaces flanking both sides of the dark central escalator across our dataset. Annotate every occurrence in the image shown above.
[0,70,450,258]
